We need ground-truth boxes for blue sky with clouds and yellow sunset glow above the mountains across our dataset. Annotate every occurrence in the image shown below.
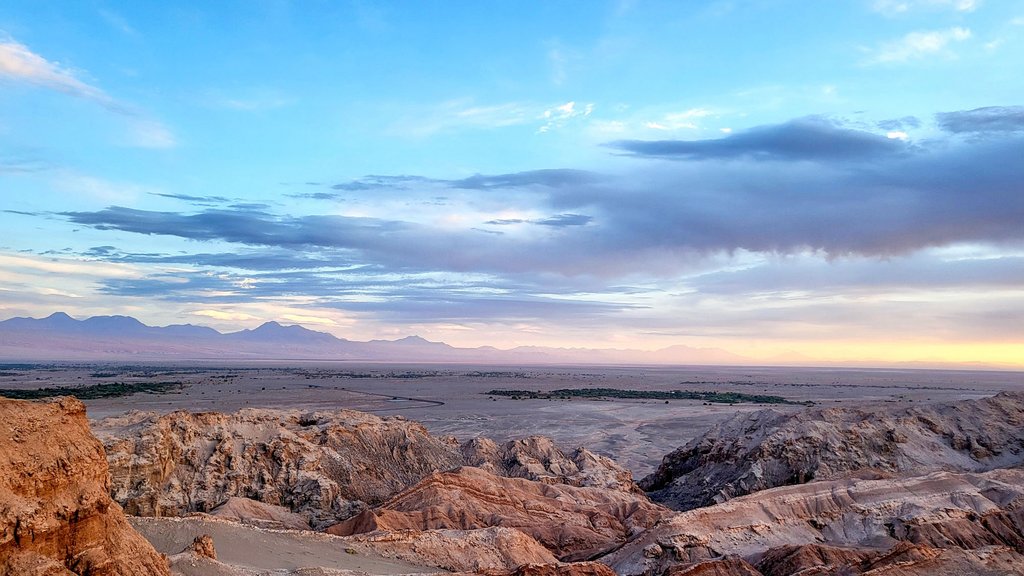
[0,0,1024,367]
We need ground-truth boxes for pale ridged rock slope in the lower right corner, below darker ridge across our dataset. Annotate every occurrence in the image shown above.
[601,468,1024,576]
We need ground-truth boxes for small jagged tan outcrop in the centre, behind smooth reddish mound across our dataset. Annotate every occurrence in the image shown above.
[462,436,640,492]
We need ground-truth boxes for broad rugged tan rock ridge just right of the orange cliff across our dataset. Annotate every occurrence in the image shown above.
[96,409,462,527]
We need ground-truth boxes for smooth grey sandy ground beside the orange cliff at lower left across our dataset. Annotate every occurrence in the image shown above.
[128,517,443,575]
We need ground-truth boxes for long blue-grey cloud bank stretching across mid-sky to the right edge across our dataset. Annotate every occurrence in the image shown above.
[54,111,1024,282]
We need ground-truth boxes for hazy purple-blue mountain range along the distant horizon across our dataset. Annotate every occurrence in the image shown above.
[0,312,753,365]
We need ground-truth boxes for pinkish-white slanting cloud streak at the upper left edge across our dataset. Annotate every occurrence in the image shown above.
[0,40,131,115]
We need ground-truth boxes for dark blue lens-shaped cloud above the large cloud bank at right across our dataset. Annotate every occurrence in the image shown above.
[609,117,907,162]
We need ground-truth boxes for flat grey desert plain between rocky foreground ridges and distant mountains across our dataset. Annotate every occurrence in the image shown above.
[0,362,1024,478]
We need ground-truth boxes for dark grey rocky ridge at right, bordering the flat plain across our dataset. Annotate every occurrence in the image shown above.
[639,393,1024,510]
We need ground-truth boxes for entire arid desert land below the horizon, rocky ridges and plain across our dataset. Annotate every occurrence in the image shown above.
[0,362,1024,576]
